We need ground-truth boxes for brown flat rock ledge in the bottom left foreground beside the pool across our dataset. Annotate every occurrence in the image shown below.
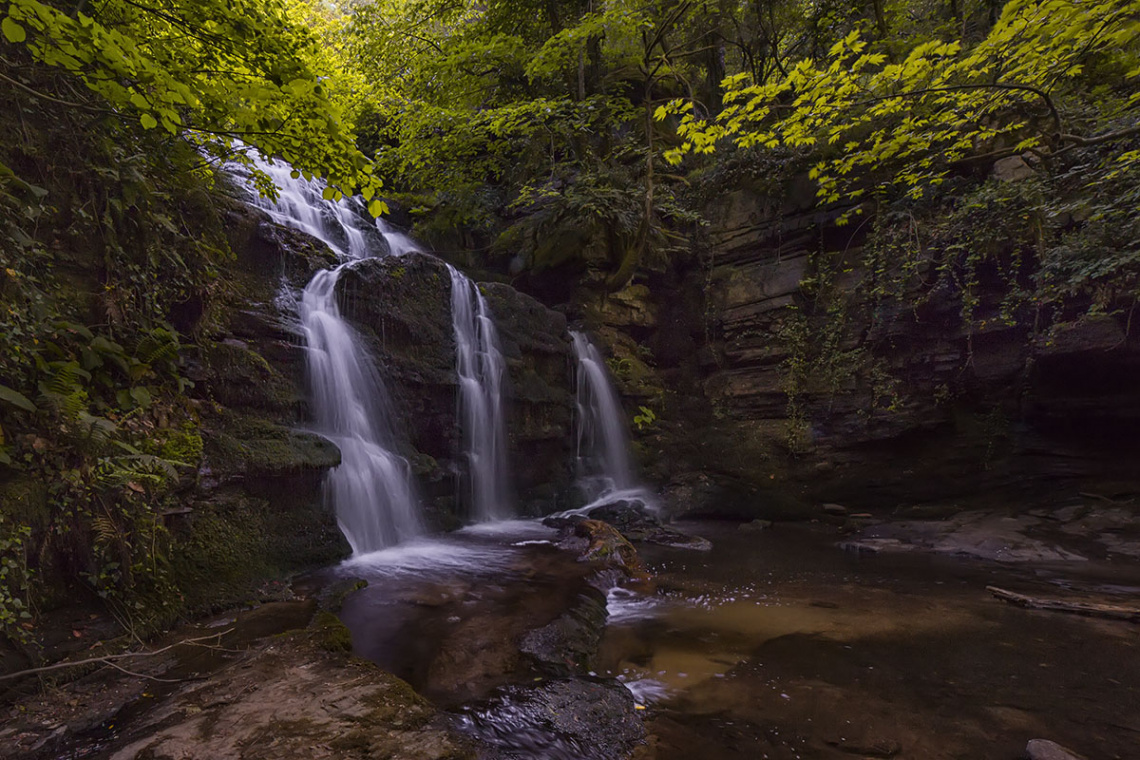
[0,600,477,760]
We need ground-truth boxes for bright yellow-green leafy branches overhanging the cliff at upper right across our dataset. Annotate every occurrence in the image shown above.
[657,0,1140,209]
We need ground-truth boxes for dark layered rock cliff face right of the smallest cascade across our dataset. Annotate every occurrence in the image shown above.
[567,176,1140,516]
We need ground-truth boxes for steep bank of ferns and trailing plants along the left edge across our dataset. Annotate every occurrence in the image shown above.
[0,63,230,640]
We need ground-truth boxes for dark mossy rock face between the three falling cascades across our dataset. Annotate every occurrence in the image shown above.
[337,253,573,525]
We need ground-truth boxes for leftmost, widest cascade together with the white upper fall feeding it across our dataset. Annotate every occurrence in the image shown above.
[240,157,424,555]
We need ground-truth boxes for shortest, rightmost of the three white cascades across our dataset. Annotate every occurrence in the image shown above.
[570,330,656,509]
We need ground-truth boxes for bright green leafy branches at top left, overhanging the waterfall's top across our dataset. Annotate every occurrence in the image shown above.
[2,0,380,201]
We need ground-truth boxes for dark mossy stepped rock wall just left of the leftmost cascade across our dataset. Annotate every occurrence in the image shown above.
[168,204,349,605]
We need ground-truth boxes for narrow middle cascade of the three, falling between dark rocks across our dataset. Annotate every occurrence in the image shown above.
[447,264,512,522]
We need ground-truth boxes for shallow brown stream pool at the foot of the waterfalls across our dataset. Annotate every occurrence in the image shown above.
[337,522,1140,760]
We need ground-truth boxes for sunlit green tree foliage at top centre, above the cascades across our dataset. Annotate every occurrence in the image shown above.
[326,0,729,283]
